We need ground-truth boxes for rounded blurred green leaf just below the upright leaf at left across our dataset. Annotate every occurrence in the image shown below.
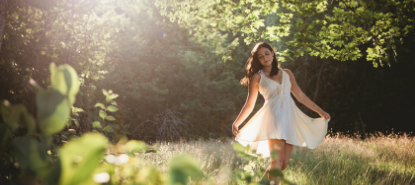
[36,89,72,135]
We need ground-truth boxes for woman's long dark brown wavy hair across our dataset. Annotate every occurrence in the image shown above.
[241,42,280,86]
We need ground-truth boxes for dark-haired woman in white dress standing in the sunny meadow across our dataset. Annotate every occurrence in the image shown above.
[232,42,330,184]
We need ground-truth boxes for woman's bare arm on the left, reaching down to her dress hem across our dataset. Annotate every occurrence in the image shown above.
[232,73,261,135]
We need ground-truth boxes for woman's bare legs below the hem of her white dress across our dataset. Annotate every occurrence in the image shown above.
[268,139,291,185]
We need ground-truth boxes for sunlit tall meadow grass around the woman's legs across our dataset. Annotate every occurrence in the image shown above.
[140,135,415,185]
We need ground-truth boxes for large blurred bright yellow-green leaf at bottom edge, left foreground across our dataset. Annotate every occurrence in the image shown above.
[59,133,108,184]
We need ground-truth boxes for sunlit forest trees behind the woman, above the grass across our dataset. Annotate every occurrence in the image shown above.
[0,0,415,141]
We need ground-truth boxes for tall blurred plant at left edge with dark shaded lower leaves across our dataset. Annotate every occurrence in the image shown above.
[1,63,79,184]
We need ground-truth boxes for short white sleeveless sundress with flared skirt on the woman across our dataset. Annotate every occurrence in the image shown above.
[235,69,329,157]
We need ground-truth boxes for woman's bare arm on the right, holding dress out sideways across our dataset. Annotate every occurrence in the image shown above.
[284,69,330,119]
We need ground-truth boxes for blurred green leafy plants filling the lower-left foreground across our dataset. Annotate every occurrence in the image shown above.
[0,63,236,185]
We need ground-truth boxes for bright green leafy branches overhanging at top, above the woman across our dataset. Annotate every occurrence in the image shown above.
[157,0,415,67]
